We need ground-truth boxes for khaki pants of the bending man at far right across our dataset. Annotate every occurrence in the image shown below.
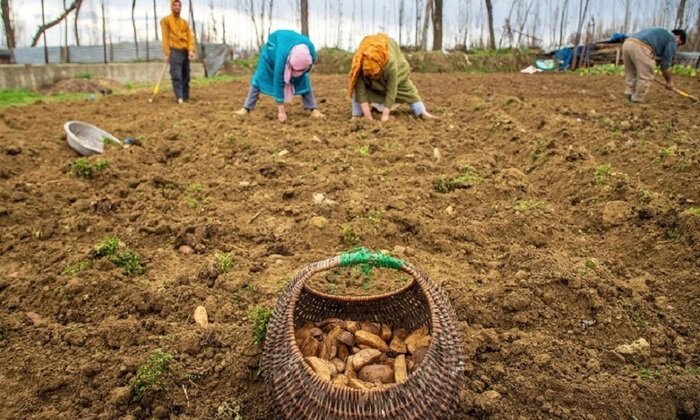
[622,38,656,102]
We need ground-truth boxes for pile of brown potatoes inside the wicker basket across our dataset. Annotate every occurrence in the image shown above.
[294,318,430,390]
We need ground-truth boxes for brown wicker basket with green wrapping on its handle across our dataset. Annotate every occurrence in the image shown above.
[263,249,464,419]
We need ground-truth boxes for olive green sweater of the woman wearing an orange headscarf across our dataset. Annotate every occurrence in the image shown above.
[355,38,421,108]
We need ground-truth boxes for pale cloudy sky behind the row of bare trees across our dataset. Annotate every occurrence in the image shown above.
[3,0,700,50]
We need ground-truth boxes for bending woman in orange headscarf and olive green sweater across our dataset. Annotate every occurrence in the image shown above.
[348,33,433,121]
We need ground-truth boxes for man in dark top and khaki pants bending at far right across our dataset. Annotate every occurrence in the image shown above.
[622,28,687,103]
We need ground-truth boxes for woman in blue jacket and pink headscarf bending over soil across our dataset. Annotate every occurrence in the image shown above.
[234,30,323,122]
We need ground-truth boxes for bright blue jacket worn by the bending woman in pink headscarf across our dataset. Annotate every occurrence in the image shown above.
[251,30,316,104]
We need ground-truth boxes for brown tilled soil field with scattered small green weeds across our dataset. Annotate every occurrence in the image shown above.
[0,74,700,419]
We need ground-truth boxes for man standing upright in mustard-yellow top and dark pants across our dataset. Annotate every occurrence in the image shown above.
[160,0,194,104]
